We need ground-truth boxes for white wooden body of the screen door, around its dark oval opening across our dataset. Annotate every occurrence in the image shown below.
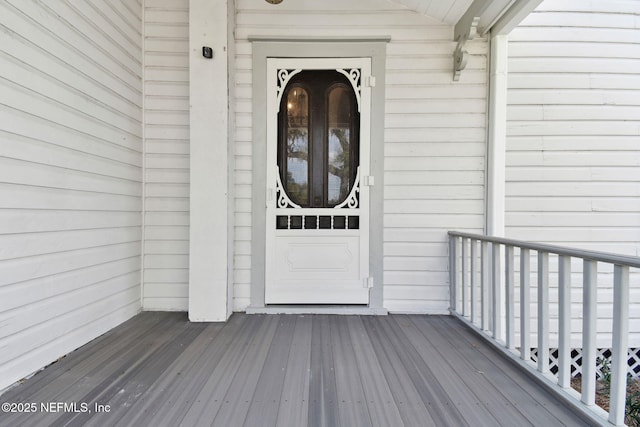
[265,58,371,305]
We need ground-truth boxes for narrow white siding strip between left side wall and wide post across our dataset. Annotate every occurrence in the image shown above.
[143,0,189,311]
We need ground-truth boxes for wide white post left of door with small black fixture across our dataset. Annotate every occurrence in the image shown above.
[189,0,231,322]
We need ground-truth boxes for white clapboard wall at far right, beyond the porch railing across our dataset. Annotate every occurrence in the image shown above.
[506,0,640,345]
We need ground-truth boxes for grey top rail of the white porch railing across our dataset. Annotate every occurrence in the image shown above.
[449,231,640,268]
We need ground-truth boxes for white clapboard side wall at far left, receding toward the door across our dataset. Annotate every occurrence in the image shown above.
[0,0,142,390]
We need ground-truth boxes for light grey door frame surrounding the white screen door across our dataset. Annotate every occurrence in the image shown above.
[247,37,390,314]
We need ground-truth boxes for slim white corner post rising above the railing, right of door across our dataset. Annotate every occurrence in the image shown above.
[486,35,508,237]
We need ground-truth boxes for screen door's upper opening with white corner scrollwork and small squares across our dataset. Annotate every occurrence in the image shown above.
[275,68,362,230]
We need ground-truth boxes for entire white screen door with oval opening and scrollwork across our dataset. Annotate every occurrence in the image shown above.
[265,58,373,304]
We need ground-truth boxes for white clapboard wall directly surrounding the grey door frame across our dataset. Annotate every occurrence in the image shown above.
[234,0,487,313]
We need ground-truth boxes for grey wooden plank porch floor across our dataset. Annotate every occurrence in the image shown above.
[0,313,586,427]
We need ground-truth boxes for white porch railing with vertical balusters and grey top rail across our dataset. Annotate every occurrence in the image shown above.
[449,231,640,425]
